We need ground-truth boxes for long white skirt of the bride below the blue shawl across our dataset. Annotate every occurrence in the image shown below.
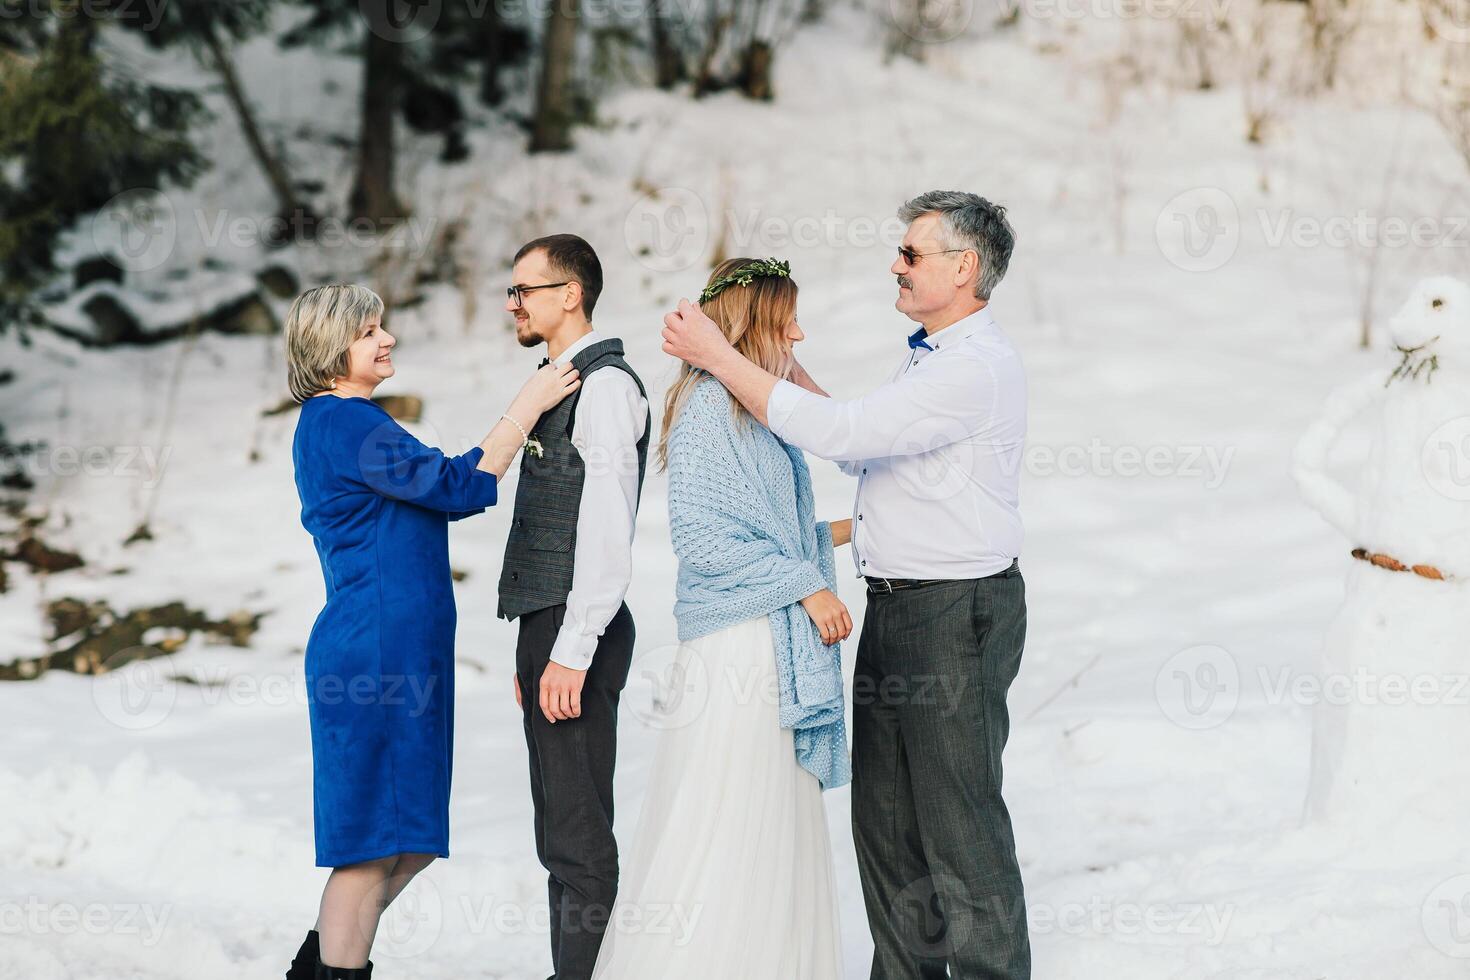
[592,616,841,980]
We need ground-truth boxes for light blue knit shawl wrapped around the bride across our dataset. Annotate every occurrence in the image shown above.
[669,378,853,789]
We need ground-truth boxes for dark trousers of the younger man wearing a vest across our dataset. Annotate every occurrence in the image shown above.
[516,604,634,980]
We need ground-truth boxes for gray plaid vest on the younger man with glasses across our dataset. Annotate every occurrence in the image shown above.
[498,338,653,620]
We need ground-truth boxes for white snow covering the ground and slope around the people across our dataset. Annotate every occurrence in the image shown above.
[0,7,1470,980]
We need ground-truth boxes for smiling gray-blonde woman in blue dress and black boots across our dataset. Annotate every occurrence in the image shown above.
[285,285,578,980]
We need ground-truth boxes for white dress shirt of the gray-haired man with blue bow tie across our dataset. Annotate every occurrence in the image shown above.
[766,309,1026,579]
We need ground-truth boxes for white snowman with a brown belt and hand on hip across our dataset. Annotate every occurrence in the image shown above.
[1292,278,1470,836]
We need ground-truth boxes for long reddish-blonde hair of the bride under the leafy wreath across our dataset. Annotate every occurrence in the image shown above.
[659,259,797,470]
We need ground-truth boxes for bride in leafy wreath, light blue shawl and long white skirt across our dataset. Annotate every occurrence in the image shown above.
[592,259,853,980]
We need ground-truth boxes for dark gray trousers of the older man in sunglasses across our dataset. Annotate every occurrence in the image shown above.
[853,564,1030,980]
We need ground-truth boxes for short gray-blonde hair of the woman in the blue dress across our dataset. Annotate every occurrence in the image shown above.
[285,284,382,401]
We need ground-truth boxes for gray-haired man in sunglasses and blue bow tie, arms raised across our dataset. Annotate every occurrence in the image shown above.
[663,191,1030,980]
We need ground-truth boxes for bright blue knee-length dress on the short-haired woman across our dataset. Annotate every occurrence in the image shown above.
[291,395,495,867]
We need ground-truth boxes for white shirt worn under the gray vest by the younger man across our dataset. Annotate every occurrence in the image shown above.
[551,331,648,670]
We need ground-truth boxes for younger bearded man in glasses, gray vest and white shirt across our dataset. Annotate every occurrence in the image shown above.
[500,235,650,980]
